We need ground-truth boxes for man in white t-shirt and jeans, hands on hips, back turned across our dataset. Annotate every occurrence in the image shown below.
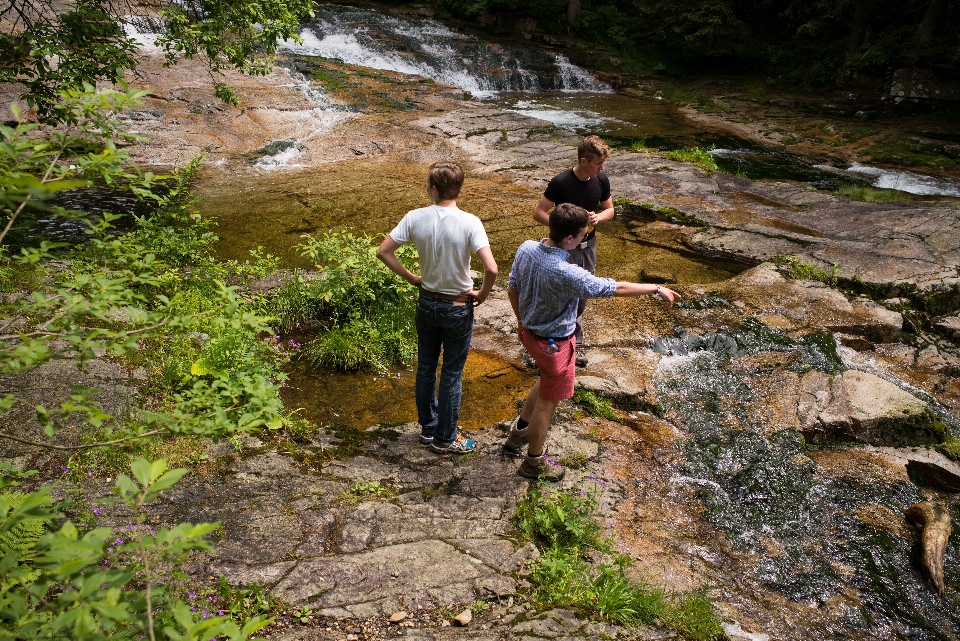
[377,162,497,454]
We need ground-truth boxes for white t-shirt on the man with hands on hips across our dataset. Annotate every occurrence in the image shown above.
[390,205,490,295]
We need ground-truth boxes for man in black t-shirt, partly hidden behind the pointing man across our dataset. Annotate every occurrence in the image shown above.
[533,136,613,352]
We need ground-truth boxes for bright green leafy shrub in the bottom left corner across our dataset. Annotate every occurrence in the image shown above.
[0,459,269,641]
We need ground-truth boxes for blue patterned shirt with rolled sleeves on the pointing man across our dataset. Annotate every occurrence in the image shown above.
[509,240,617,338]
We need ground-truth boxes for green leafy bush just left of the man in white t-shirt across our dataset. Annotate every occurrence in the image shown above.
[294,233,417,371]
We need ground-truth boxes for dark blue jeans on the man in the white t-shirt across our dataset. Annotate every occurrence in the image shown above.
[416,296,473,444]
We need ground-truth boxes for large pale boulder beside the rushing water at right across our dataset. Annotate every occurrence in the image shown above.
[797,370,946,446]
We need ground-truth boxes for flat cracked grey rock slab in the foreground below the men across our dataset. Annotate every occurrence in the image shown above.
[152,423,599,625]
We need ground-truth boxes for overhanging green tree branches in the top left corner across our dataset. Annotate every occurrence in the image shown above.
[0,0,313,122]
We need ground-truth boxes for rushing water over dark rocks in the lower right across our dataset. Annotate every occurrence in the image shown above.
[654,321,960,641]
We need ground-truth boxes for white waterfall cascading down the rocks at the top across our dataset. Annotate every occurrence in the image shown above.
[285,5,612,96]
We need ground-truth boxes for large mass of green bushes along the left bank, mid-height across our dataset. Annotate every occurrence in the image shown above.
[0,90,283,456]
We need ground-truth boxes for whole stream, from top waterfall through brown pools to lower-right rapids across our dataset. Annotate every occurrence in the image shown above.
[73,5,960,641]
